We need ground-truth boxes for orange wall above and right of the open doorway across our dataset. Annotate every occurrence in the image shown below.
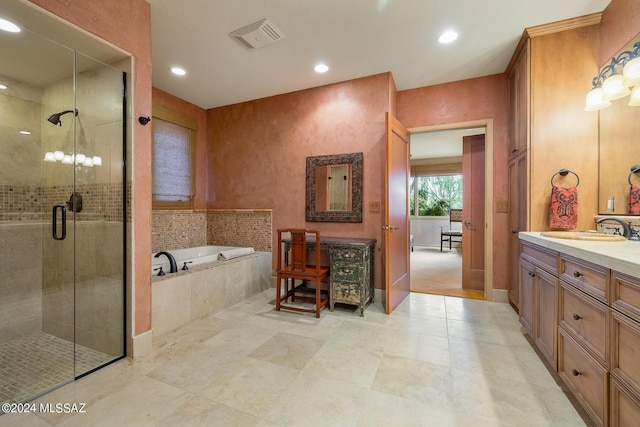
[397,74,509,289]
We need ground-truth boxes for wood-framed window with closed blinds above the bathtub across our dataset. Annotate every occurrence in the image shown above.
[152,117,195,208]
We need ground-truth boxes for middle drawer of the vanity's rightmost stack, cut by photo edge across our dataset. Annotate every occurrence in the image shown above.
[611,310,640,393]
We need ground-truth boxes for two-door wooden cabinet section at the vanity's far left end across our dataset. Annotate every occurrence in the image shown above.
[519,243,558,369]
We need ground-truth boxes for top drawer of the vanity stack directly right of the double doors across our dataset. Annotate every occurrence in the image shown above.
[560,255,609,303]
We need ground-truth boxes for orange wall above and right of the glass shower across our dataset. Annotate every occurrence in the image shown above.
[30,0,151,336]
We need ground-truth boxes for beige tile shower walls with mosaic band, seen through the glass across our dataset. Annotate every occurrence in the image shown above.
[0,63,124,354]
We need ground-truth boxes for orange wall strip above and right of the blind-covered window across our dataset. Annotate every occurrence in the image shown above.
[153,87,208,210]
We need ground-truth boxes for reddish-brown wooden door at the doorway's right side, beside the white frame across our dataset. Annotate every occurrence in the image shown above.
[462,135,485,291]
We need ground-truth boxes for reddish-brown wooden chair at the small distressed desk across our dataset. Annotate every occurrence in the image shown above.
[276,228,329,317]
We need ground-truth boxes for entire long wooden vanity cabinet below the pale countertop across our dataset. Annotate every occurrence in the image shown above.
[519,237,640,426]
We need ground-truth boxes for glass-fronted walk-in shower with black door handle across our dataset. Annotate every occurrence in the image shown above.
[0,14,127,408]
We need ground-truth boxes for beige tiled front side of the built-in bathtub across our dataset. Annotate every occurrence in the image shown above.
[151,247,271,337]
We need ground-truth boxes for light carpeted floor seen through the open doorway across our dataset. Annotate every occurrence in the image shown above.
[411,246,484,299]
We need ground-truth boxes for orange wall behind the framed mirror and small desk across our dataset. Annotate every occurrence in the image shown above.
[207,73,395,287]
